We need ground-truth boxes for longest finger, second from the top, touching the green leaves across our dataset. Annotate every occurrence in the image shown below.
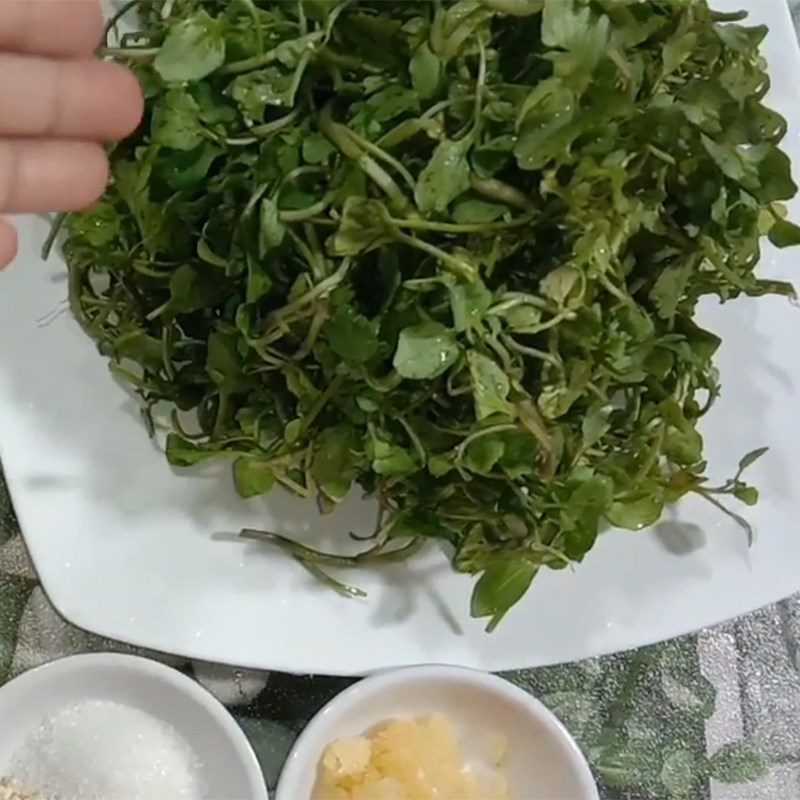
[0,54,143,139]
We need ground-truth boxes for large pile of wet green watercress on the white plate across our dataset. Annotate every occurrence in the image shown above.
[53,0,800,626]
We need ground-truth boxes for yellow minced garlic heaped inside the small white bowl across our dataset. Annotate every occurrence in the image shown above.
[314,714,509,800]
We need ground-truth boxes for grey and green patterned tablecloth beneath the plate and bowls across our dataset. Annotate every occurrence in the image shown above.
[0,0,800,800]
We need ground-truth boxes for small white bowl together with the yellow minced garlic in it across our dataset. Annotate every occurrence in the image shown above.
[275,666,598,800]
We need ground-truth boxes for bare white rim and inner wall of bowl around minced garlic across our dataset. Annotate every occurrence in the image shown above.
[275,666,598,800]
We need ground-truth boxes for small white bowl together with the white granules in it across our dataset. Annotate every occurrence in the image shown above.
[0,653,267,800]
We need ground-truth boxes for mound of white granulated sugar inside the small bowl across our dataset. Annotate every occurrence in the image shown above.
[11,701,203,800]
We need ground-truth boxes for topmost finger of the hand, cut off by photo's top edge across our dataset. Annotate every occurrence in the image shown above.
[0,0,103,57]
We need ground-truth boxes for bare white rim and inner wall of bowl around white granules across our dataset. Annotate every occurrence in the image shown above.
[0,653,268,800]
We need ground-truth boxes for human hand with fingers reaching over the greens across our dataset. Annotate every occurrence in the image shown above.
[0,0,142,269]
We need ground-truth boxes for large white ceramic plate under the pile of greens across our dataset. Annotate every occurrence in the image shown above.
[0,0,800,675]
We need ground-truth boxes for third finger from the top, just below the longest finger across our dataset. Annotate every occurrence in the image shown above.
[0,141,108,213]
